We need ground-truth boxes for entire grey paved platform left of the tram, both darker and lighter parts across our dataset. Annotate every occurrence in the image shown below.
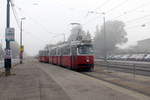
[0,60,150,100]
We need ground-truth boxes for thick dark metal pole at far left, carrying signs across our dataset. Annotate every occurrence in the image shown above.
[4,0,11,76]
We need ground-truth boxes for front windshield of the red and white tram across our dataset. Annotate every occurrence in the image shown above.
[78,45,94,54]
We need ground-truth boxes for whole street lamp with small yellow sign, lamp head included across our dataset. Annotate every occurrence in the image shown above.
[20,17,26,64]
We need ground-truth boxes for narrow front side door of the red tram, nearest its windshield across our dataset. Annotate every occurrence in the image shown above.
[71,46,77,69]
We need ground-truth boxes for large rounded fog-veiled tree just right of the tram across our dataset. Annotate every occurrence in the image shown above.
[94,21,128,56]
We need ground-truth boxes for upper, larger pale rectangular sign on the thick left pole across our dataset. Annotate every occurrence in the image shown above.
[5,28,15,41]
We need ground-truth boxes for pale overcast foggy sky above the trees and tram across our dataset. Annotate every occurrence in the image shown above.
[0,0,150,55]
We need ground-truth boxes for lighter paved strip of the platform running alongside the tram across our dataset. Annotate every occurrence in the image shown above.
[40,64,150,100]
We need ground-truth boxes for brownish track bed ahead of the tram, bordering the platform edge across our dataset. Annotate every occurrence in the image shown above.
[81,70,150,96]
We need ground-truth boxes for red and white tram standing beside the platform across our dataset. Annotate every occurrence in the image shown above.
[39,41,94,70]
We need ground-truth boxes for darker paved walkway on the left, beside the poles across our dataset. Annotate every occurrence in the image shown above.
[0,59,70,100]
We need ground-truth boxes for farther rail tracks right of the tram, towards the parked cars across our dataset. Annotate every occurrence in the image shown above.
[95,61,150,76]
